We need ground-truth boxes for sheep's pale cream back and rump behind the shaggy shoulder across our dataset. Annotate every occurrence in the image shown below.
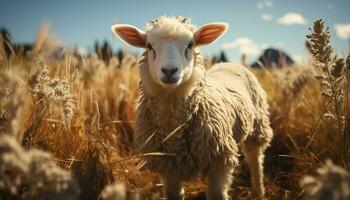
[207,63,273,147]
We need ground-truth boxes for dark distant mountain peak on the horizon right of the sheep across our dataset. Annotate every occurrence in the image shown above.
[251,48,294,68]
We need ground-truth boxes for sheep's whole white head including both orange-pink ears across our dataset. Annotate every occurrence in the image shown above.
[112,17,228,88]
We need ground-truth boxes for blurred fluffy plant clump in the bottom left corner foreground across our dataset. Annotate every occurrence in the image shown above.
[0,134,80,200]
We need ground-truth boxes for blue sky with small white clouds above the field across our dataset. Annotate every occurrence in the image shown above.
[0,0,350,62]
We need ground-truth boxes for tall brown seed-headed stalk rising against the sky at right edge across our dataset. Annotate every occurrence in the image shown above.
[305,19,347,158]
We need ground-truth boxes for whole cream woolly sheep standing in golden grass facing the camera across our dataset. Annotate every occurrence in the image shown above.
[111,16,273,199]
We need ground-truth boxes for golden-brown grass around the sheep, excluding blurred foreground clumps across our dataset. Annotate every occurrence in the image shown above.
[0,19,350,200]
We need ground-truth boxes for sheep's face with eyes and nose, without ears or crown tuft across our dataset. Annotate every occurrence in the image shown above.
[146,28,194,88]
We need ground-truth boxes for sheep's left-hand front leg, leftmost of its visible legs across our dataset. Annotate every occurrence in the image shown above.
[163,175,185,200]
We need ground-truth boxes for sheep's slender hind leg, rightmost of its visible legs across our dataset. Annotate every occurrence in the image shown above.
[242,144,265,197]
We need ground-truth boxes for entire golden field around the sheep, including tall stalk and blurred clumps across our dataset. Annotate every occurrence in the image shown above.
[0,20,350,200]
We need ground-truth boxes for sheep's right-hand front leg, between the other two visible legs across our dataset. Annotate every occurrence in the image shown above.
[207,164,233,200]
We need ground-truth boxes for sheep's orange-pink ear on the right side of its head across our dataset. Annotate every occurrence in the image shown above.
[193,22,228,46]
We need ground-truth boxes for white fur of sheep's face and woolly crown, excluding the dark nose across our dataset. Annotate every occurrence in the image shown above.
[146,18,194,88]
